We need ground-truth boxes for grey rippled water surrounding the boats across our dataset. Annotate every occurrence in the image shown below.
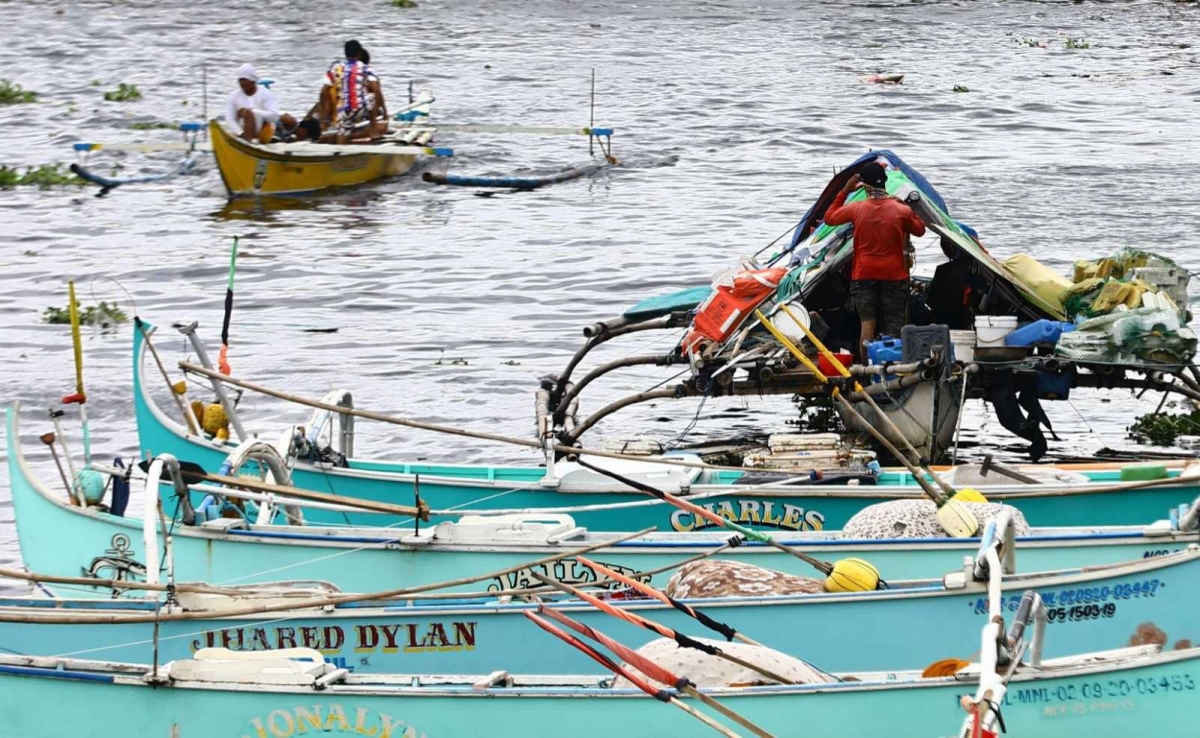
[0,0,1200,571]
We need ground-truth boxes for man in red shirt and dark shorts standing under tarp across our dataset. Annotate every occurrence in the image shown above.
[824,162,925,361]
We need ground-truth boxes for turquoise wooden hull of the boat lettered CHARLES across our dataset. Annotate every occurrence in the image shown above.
[133,329,1200,533]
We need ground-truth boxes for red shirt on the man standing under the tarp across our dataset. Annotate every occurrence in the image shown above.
[824,191,925,281]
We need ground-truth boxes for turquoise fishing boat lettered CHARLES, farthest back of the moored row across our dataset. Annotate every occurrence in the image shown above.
[133,323,1200,533]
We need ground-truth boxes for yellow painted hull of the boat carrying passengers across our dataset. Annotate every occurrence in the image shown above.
[209,120,418,197]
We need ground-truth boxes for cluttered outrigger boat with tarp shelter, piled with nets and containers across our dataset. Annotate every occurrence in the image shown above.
[536,150,1200,468]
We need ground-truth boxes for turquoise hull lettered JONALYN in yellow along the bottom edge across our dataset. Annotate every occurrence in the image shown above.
[0,648,1200,738]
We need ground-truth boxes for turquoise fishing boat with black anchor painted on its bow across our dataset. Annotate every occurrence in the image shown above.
[14,409,1195,596]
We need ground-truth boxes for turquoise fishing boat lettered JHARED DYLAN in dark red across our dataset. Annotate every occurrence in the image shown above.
[0,542,1200,674]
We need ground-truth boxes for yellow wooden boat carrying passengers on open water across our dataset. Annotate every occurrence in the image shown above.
[209,92,449,197]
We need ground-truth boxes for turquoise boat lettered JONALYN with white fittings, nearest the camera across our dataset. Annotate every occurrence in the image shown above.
[0,592,1200,738]
